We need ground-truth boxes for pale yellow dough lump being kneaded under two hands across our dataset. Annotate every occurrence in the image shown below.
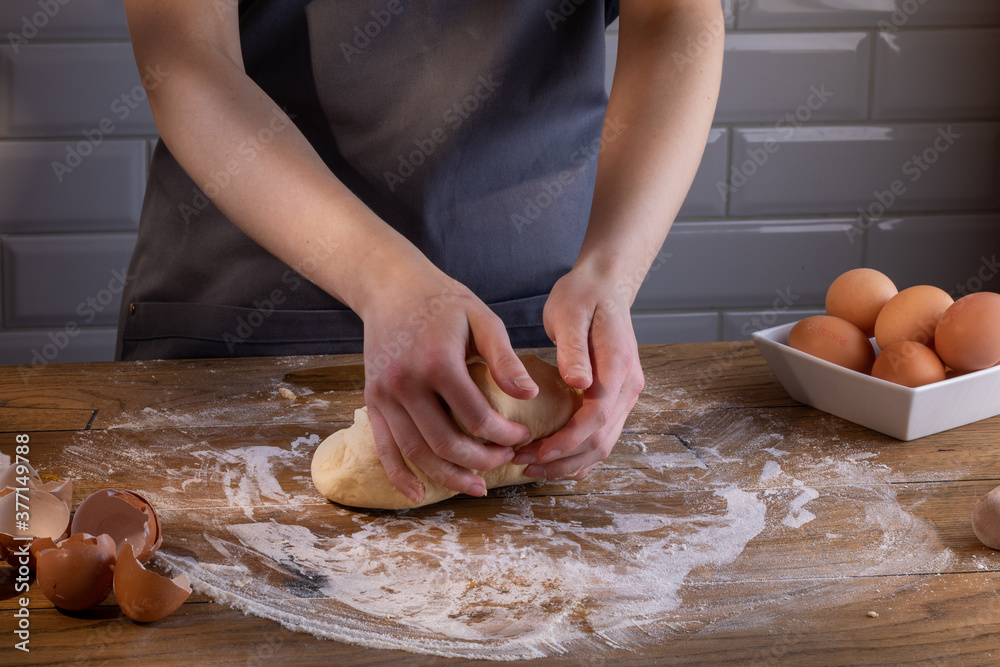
[312,354,583,509]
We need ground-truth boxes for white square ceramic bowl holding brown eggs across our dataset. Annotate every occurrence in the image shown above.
[752,322,1000,440]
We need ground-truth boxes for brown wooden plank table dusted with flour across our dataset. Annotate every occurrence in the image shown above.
[0,343,1000,665]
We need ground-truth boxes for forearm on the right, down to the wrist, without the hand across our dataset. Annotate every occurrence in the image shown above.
[576,0,724,305]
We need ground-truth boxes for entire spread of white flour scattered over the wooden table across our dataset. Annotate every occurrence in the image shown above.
[56,408,951,660]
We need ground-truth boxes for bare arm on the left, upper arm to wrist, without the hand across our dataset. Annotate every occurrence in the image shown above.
[125,0,422,312]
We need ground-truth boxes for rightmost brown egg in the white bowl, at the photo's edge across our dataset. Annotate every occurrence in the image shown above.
[934,292,1000,372]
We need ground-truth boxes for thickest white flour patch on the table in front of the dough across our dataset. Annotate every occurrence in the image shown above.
[161,488,766,660]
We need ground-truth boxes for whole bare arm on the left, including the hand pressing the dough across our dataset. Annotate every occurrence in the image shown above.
[125,0,537,500]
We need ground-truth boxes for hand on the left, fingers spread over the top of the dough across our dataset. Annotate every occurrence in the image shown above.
[362,271,538,503]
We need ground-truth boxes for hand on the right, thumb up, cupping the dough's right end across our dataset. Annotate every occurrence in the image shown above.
[513,268,645,479]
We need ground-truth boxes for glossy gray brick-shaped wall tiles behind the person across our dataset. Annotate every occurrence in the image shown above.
[0,0,1000,364]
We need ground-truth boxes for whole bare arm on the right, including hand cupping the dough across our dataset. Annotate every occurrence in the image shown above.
[515,0,724,478]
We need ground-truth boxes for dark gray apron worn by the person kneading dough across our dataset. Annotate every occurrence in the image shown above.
[117,0,617,359]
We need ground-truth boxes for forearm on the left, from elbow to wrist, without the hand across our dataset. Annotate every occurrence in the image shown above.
[144,49,434,313]
